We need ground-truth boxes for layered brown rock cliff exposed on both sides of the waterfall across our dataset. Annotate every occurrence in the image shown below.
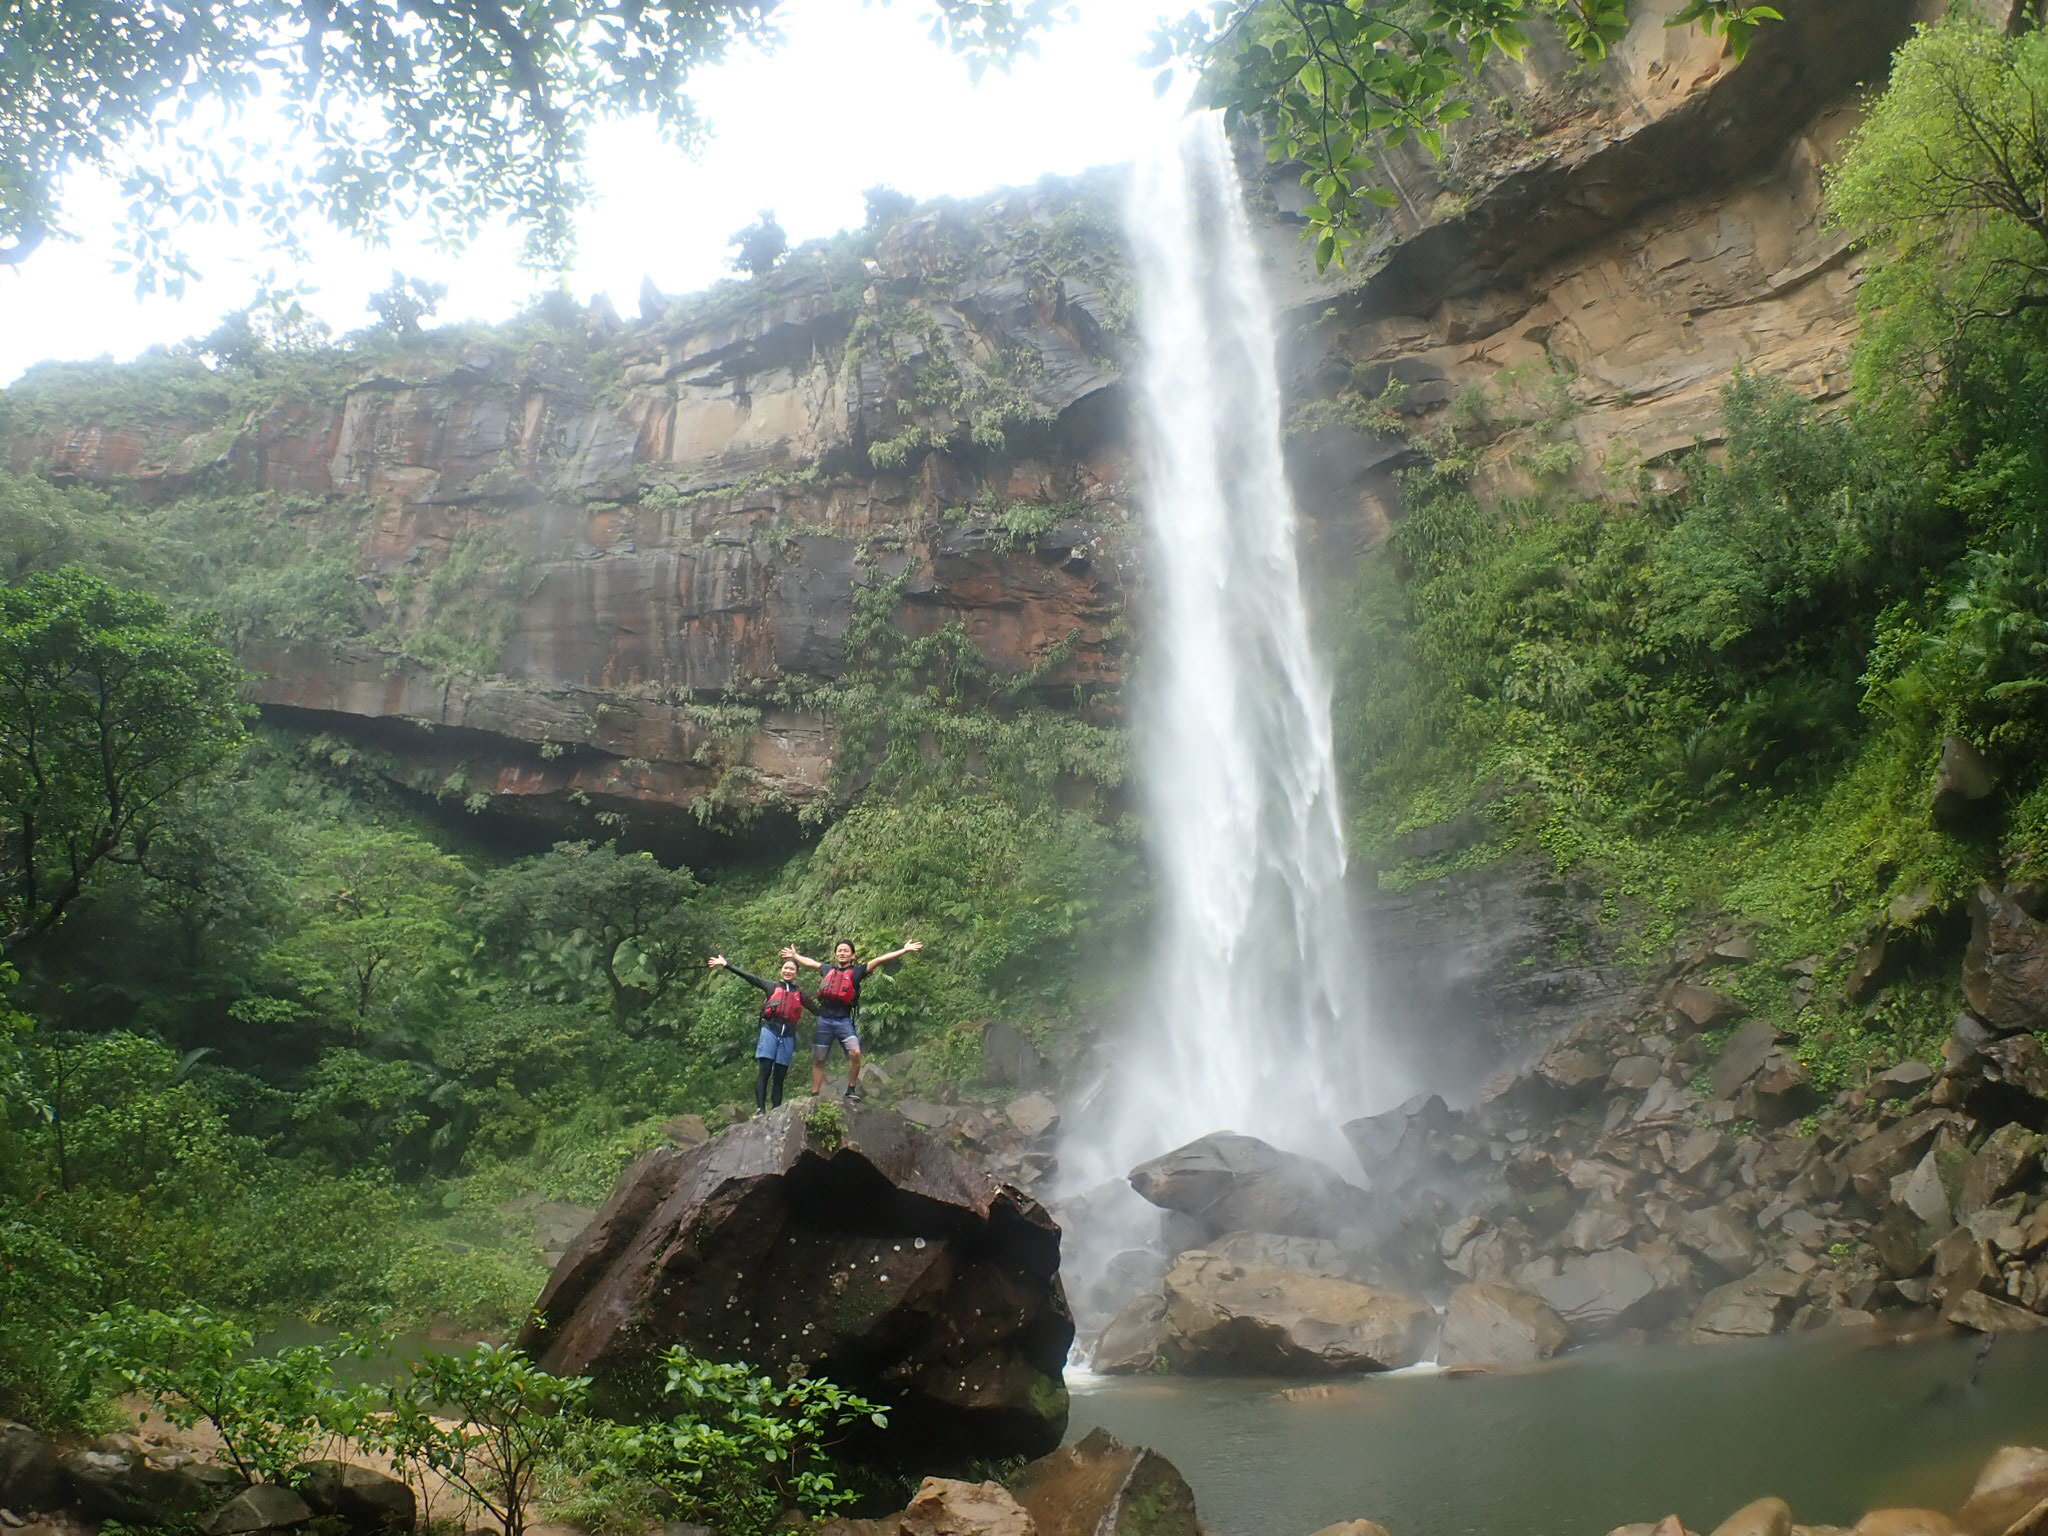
[0,0,1923,1077]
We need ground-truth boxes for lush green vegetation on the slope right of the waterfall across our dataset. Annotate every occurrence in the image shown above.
[1307,20,2048,1083]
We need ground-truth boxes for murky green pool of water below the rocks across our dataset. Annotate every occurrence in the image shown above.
[1069,1333,2048,1536]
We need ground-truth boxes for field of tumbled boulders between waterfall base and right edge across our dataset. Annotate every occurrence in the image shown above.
[1065,885,2048,1374]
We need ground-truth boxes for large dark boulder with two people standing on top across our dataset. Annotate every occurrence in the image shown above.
[520,1104,1073,1470]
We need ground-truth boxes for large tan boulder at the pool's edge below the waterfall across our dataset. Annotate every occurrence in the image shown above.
[1165,1249,1436,1374]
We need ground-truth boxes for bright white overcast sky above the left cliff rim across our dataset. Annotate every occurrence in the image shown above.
[0,0,1188,383]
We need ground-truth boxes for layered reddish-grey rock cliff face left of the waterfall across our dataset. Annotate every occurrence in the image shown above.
[6,188,1128,847]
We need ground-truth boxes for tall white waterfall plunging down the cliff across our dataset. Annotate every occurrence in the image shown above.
[1061,113,1403,1302]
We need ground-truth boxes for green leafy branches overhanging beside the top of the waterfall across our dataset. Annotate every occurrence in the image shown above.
[1153,0,1782,268]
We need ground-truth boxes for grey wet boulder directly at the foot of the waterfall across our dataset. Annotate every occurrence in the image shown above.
[1130,1130,1364,1237]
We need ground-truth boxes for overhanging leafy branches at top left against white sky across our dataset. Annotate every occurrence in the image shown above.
[0,0,1055,287]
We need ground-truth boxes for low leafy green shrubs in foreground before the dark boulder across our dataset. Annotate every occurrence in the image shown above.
[61,1305,887,1536]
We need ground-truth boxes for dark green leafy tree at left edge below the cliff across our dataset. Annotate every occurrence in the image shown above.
[0,565,248,946]
